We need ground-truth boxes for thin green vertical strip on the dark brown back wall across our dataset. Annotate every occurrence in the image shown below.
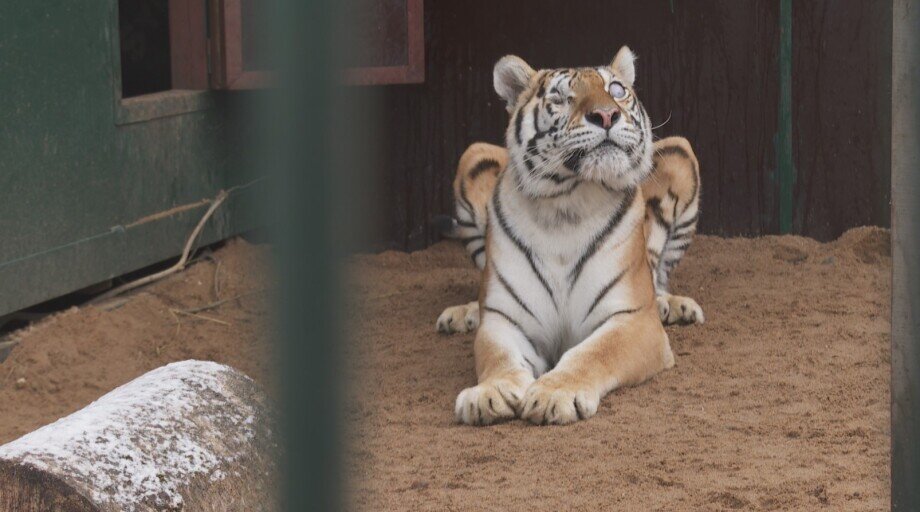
[776,0,795,233]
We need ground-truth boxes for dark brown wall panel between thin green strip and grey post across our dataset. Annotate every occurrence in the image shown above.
[792,0,892,240]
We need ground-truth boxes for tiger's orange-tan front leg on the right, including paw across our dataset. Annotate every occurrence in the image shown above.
[521,304,674,425]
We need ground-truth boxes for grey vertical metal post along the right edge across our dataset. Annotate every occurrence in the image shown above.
[891,0,920,511]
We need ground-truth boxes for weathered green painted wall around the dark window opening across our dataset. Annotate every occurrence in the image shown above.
[0,0,258,314]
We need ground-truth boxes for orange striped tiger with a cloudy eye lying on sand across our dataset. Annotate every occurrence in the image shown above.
[438,47,704,425]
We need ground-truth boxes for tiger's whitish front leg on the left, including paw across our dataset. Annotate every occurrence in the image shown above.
[454,310,547,425]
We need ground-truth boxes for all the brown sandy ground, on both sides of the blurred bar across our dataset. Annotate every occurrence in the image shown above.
[0,229,891,511]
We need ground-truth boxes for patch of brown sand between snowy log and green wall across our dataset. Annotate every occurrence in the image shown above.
[0,240,271,444]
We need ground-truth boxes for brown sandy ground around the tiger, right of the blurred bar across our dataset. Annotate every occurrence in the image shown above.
[347,228,891,511]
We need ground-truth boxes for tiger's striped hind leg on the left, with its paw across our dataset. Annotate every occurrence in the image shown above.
[432,142,508,334]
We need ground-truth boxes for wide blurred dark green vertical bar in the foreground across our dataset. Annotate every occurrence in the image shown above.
[270,0,342,512]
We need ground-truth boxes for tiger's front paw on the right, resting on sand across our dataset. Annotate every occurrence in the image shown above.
[521,374,601,425]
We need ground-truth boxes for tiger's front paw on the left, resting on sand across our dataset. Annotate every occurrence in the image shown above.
[454,379,525,425]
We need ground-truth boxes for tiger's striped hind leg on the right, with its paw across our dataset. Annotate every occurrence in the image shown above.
[642,137,706,325]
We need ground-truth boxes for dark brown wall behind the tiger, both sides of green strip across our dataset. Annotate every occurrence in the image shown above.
[368,0,891,250]
